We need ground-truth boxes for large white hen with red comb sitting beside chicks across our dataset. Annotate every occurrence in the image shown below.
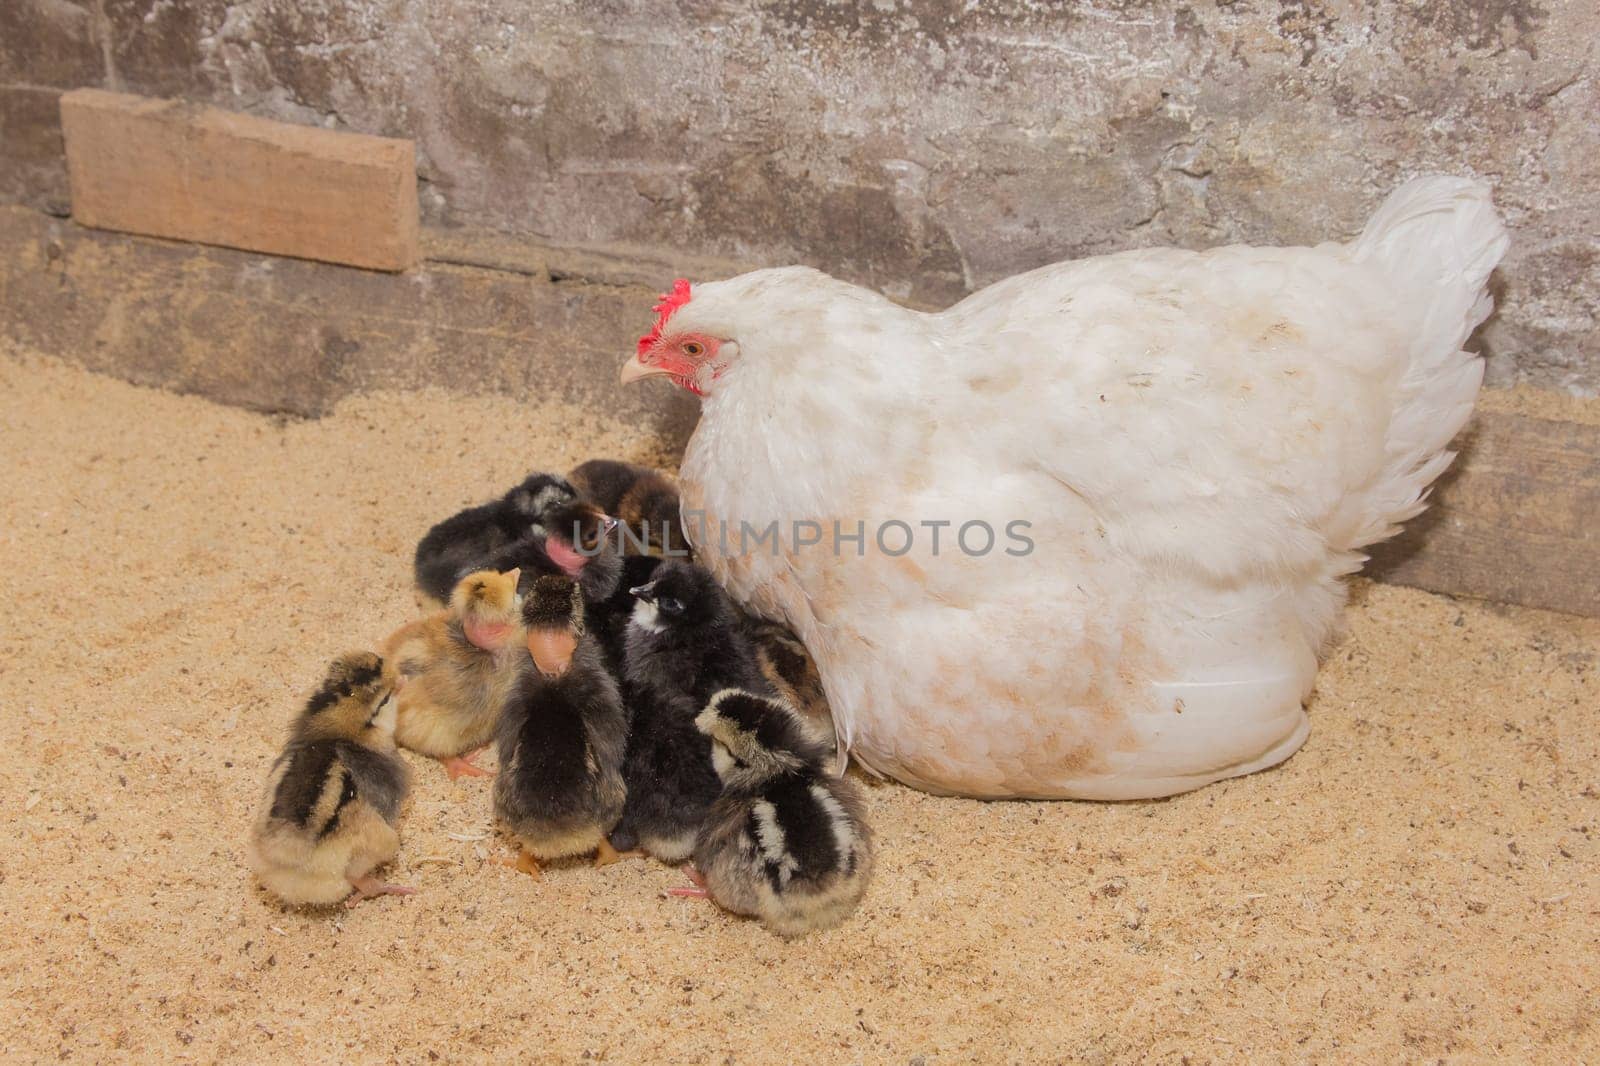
[622,178,1506,799]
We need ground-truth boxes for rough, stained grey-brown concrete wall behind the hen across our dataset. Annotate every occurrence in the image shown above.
[0,0,1600,392]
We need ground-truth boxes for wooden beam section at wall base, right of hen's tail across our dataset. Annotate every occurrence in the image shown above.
[1368,410,1600,616]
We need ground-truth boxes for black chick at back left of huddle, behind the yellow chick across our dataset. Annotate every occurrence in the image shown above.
[414,474,578,607]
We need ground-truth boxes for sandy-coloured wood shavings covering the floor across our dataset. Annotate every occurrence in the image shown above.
[0,351,1600,1064]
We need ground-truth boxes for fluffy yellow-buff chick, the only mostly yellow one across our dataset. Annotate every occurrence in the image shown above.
[384,570,523,781]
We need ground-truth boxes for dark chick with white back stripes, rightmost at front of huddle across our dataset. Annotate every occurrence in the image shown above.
[672,690,872,936]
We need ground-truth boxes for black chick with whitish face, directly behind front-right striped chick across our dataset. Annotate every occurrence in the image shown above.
[611,560,776,863]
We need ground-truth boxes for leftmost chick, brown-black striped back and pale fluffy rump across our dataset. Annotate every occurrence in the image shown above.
[248,651,411,906]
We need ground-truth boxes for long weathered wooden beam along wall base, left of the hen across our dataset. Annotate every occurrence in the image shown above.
[0,206,699,444]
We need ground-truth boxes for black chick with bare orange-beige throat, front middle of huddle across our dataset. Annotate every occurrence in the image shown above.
[494,575,627,877]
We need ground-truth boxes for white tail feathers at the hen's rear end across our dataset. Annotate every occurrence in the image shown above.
[1328,176,1509,550]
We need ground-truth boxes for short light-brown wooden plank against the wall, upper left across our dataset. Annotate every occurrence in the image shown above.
[61,90,418,271]
